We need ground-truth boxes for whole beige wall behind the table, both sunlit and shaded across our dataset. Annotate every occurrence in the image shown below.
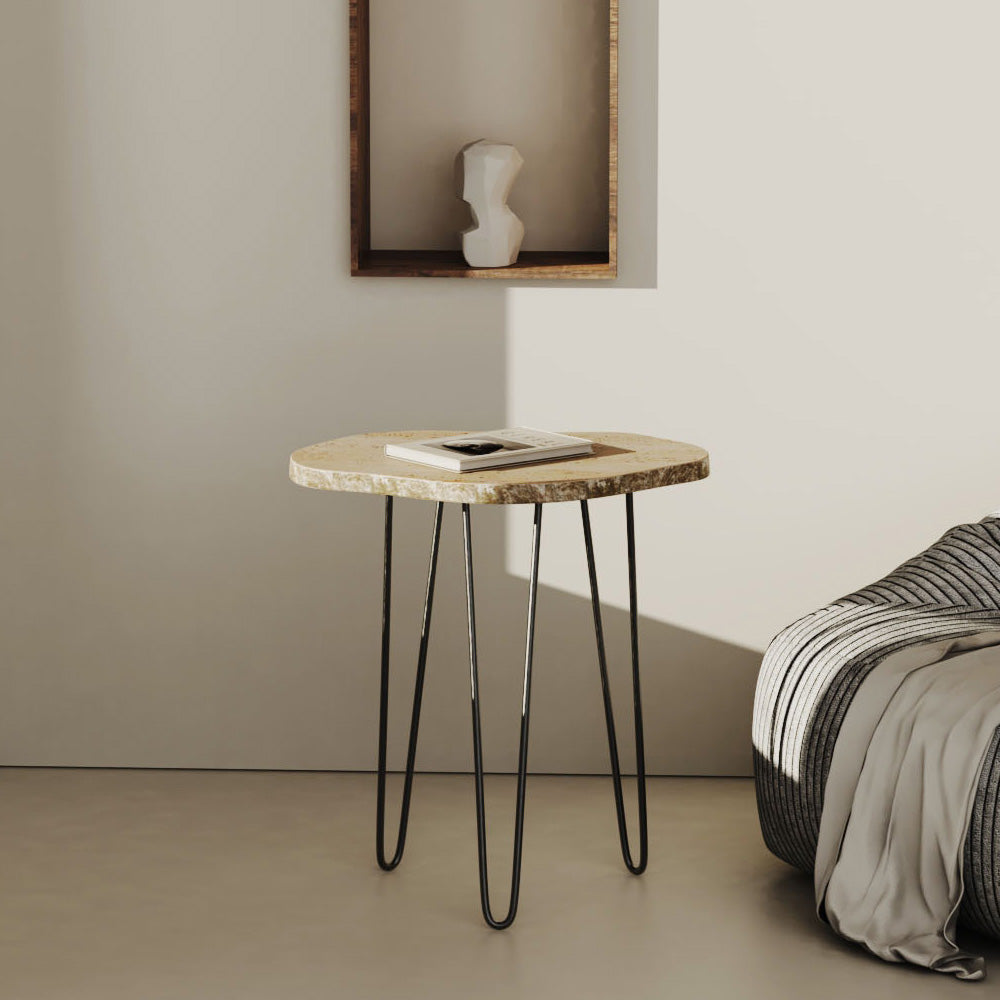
[0,0,1000,773]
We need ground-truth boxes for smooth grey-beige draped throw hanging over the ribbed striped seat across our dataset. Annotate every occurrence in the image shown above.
[815,631,1000,979]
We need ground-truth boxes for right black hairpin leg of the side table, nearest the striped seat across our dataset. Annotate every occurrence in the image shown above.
[580,493,649,875]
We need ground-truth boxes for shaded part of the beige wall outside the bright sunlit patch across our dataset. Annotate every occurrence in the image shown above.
[0,0,756,773]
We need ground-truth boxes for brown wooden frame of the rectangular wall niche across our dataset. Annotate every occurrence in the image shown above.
[350,0,618,281]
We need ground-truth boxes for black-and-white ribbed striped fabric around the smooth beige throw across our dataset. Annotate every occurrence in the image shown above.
[753,515,1000,938]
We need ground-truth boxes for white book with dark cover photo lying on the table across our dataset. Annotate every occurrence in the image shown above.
[385,427,594,472]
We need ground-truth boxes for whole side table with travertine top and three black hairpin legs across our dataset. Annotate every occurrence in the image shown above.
[289,431,708,929]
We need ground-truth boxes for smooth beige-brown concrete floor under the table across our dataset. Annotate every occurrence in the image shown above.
[0,769,1000,1000]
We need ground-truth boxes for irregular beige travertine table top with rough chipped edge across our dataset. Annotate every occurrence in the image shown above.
[288,430,708,504]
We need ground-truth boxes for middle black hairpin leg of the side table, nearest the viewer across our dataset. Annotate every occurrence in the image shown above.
[462,504,542,930]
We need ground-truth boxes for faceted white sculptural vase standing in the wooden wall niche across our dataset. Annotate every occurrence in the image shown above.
[458,139,524,267]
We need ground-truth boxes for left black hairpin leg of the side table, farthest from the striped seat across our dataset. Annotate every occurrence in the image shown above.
[375,496,444,871]
